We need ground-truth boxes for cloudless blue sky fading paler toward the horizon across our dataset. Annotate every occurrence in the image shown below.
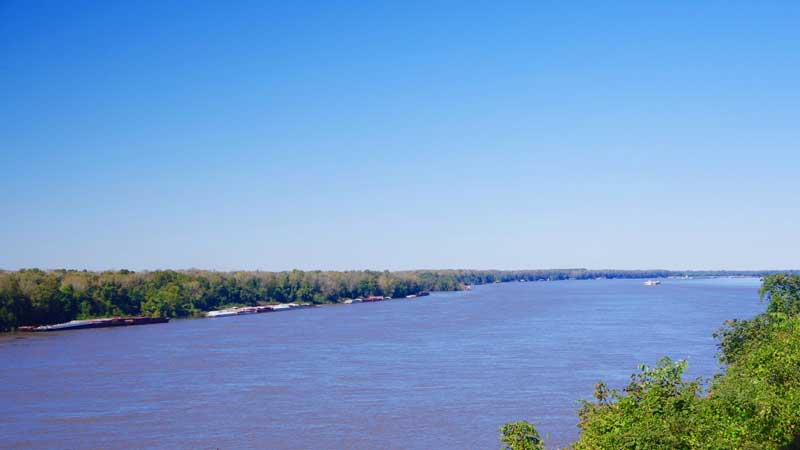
[0,0,800,270]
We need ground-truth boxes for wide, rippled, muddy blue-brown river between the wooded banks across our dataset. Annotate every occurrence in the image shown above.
[0,279,764,450]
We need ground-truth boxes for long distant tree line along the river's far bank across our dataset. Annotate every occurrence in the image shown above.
[0,269,792,331]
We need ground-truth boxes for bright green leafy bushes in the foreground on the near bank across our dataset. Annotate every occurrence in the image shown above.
[501,275,800,450]
